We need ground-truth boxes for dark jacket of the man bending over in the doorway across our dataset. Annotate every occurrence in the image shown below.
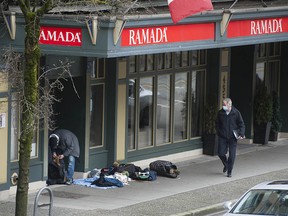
[53,129,80,158]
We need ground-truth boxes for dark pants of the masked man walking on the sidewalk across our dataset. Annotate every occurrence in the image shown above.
[218,137,237,174]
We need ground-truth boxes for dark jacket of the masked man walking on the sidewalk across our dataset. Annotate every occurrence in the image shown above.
[216,106,245,139]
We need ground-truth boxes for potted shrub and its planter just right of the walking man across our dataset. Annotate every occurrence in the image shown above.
[253,85,272,144]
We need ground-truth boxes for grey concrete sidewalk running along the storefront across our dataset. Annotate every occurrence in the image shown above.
[0,139,288,216]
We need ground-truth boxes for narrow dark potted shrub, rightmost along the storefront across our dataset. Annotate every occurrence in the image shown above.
[269,91,282,141]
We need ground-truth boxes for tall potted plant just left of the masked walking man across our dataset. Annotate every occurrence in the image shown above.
[202,97,218,155]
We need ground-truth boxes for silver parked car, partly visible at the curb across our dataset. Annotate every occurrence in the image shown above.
[224,180,288,216]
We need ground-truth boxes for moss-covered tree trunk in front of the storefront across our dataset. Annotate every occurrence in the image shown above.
[15,12,40,216]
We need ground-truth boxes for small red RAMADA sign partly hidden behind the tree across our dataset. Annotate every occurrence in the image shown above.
[39,26,82,46]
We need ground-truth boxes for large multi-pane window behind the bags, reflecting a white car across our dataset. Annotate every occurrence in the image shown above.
[127,50,206,151]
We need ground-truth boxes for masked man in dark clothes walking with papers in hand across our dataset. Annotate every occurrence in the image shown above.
[216,98,245,177]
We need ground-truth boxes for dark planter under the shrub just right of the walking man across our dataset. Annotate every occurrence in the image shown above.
[253,122,271,144]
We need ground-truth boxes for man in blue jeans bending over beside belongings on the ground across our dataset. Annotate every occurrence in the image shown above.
[49,129,80,185]
